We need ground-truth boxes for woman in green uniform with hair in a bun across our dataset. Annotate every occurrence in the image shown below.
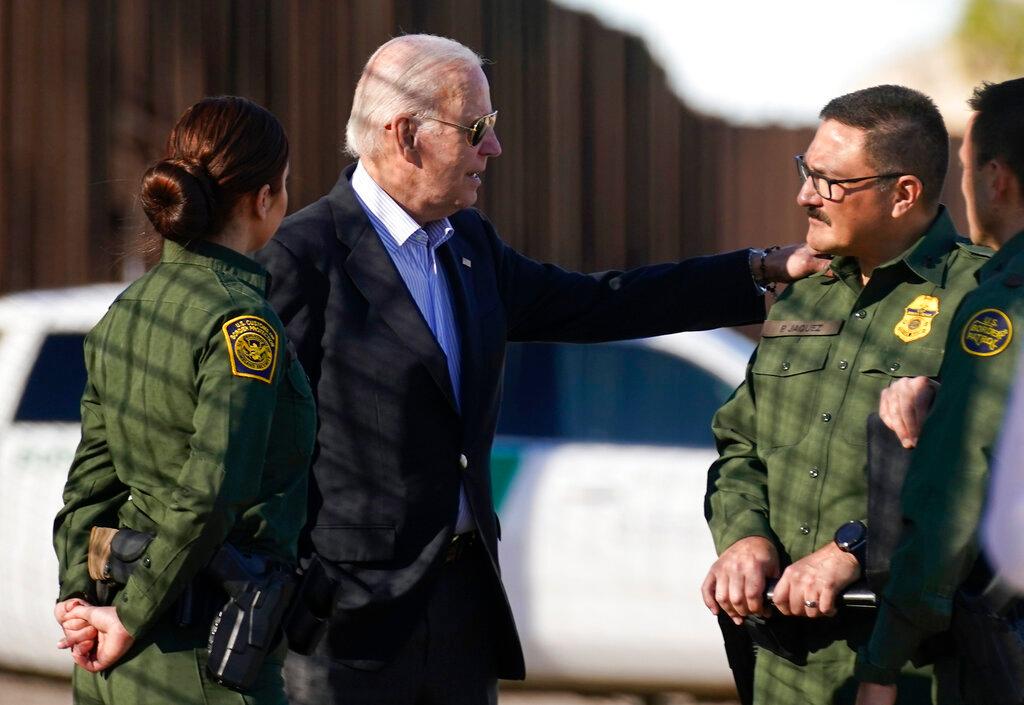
[53,96,315,705]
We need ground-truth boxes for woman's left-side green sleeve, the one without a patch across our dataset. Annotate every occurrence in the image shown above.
[53,381,128,602]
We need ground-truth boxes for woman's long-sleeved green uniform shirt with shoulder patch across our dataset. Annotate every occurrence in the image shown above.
[54,236,315,638]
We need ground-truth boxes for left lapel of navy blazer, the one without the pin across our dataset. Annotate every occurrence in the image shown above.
[330,166,458,410]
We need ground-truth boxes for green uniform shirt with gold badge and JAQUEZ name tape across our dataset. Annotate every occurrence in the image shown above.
[707,209,986,565]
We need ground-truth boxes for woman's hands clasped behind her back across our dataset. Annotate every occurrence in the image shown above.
[53,597,135,673]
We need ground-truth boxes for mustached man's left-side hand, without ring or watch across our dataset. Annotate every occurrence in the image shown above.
[700,536,779,625]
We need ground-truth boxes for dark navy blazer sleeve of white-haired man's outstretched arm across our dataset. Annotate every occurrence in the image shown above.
[483,220,765,342]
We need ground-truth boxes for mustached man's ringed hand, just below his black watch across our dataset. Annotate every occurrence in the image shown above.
[772,541,860,617]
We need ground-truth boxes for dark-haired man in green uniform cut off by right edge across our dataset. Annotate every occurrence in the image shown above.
[856,78,1024,705]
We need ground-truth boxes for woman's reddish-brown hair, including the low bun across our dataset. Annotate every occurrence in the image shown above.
[141,95,288,240]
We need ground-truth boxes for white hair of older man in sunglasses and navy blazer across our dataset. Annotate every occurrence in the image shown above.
[345,34,483,158]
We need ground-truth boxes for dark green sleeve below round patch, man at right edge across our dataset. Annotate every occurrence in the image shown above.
[857,325,1018,682]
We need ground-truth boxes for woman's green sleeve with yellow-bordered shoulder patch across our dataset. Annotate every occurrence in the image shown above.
[115,312,287,638]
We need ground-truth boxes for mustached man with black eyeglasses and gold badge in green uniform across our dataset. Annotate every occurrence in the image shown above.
[701,86,987,705]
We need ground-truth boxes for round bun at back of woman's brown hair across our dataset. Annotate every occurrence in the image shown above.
[141,160,217,240]
